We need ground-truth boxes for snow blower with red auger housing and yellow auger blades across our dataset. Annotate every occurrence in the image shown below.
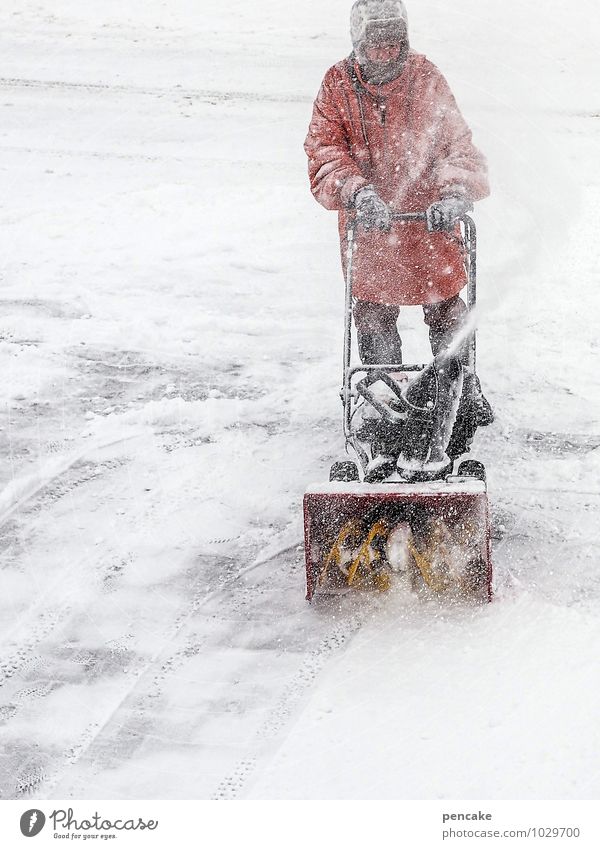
[304,213,492,601]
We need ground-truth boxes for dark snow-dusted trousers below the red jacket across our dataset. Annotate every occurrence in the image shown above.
[353,295,467,365]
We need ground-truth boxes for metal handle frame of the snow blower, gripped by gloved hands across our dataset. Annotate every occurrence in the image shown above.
[340,212,477,444]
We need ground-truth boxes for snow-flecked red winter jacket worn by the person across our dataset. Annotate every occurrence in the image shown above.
[304,51,489,305]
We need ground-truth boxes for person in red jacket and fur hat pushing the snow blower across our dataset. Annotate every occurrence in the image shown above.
[304,0,493,425]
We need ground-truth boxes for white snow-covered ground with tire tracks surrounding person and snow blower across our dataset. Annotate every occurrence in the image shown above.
[0,0,600,799]
